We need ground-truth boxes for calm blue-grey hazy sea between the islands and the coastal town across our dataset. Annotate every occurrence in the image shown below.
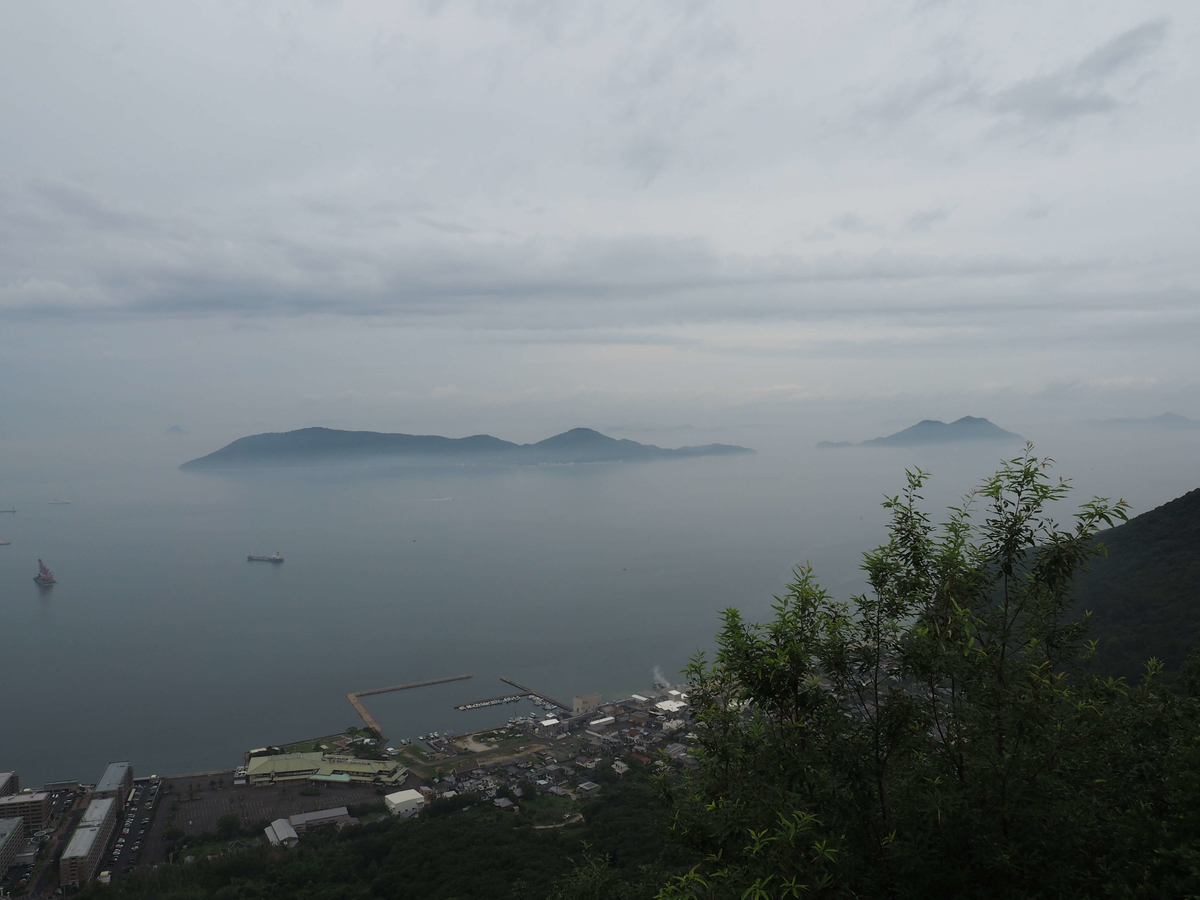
[0,424,1200,785]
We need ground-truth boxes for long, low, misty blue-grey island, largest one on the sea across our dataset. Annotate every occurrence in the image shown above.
[179,428,754,470]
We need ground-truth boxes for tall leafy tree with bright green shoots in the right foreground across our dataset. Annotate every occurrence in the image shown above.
[662,449,1200,899]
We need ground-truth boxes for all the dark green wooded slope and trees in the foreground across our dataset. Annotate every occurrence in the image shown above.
[85,450,1200,900]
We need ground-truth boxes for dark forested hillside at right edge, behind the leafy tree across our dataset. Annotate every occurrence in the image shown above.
[1078,490,1200,678]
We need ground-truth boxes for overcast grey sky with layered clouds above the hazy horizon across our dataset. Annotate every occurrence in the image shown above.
[0,0,1200,446]
